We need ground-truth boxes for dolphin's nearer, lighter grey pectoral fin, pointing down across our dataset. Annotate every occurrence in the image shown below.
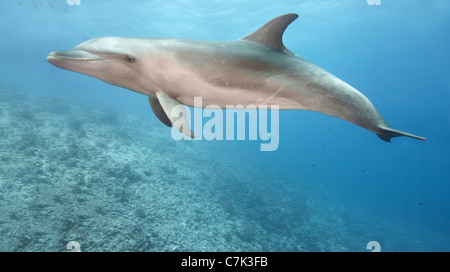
[154,92,195,138]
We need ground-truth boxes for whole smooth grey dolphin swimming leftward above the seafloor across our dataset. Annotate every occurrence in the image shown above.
[47,14,425,142]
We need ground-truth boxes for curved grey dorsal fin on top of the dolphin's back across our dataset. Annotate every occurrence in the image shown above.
[241,13,298,50]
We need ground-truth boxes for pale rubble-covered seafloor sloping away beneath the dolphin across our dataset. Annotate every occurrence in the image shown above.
[0,88,442,251]
